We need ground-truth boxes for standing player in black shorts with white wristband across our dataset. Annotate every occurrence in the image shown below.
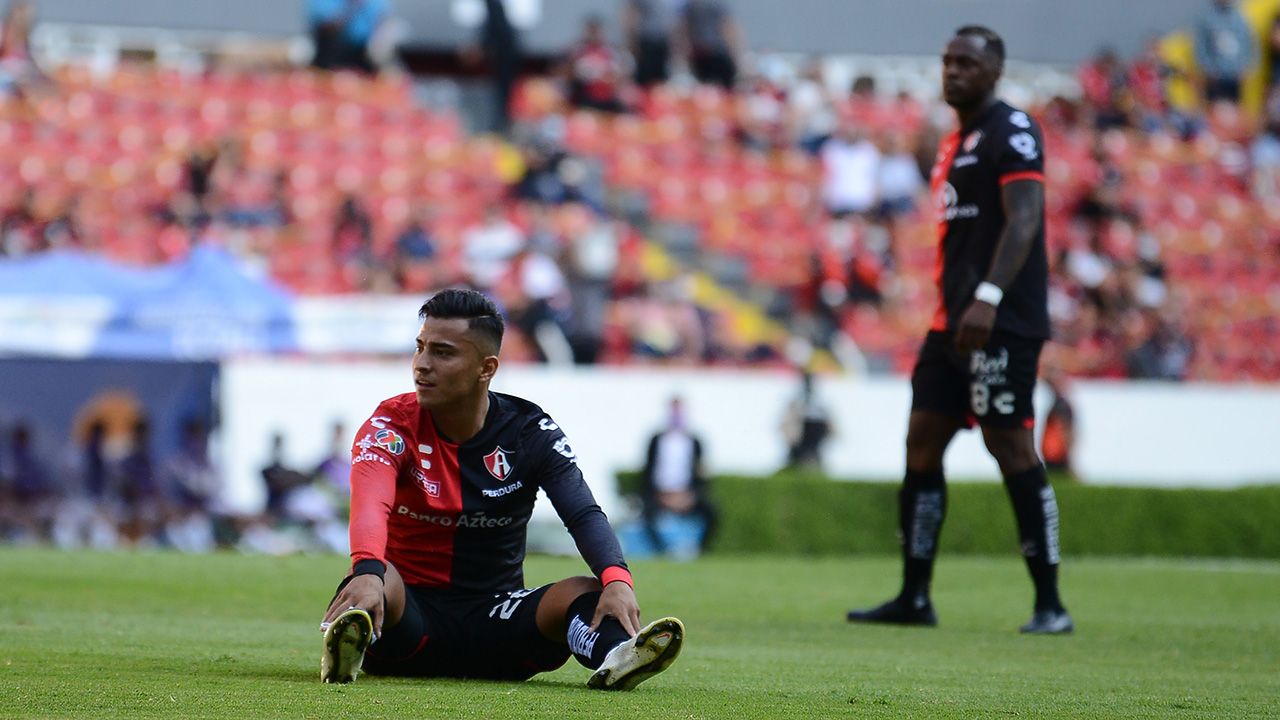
[849,26,1073,634]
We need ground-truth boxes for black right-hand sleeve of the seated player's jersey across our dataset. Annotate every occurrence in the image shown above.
[526,415,627,578]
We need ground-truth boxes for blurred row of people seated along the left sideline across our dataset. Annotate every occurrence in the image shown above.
[0,409,351,553]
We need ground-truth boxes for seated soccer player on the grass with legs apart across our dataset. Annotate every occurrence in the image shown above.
[320,290,684,689]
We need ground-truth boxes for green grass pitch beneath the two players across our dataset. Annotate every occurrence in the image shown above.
[0,548,1280,720]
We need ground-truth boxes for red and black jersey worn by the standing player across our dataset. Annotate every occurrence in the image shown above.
[931,101,1050,338]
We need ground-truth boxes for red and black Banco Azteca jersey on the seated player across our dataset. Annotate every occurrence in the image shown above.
[351,392,628,592]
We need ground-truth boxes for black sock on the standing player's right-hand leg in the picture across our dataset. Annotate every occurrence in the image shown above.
[1005,462,1062,611]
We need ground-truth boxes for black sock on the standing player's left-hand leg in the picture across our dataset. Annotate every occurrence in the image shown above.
[897,470,947,602]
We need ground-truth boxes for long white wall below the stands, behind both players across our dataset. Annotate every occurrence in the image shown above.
[221,359,1280,510]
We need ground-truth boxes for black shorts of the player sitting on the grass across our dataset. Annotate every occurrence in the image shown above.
[335,580,570,680]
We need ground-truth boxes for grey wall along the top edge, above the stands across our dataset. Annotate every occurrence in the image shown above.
[24,0,1208,64]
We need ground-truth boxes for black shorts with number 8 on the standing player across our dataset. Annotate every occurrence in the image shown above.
[911,331,1044,428]
